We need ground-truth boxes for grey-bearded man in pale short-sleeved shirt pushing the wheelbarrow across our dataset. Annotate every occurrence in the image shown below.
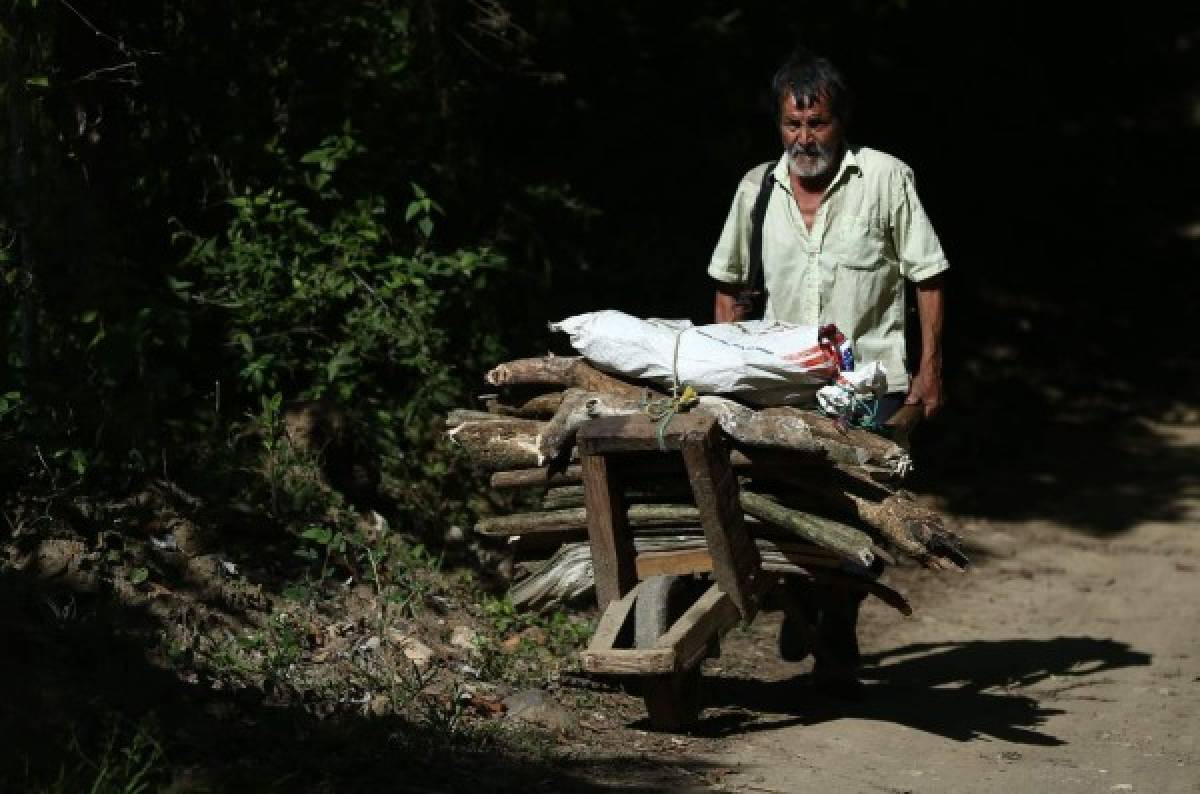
[708,50,948,684]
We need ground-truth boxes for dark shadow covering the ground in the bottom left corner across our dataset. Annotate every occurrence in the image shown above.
[0,570,703,793]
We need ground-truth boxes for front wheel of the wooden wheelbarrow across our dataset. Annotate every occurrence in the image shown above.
[634,576,702,732]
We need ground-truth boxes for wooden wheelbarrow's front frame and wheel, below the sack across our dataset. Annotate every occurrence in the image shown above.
[578,414,768,730]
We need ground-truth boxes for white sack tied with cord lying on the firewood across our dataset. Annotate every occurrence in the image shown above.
[550,309,850,404]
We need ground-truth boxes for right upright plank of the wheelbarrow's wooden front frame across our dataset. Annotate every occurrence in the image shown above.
[680,425,761,621]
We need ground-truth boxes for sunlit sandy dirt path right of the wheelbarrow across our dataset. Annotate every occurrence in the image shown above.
[676,425,1200,793]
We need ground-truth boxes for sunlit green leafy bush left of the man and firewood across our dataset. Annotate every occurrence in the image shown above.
[182,128,504,435]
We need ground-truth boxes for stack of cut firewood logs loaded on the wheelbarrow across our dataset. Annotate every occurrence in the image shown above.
[446,356,967,613]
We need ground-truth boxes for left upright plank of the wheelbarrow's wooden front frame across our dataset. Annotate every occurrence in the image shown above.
[582,455,637,610]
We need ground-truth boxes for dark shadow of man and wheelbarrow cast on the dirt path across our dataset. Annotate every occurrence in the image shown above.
[696,637,1151,746]
